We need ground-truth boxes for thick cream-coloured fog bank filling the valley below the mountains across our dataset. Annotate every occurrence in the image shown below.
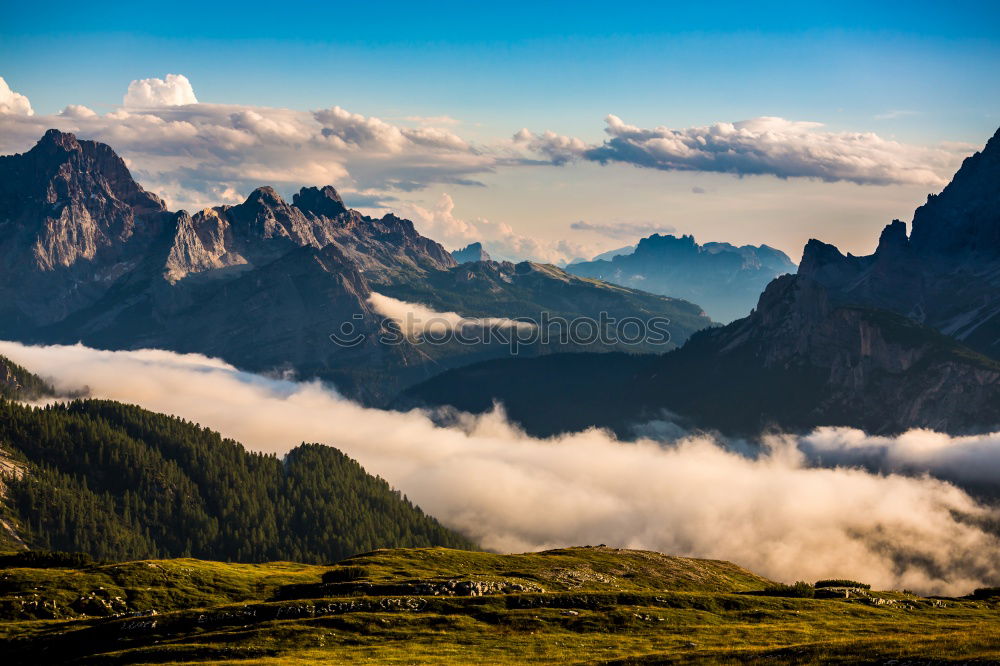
[0,342,1000,593]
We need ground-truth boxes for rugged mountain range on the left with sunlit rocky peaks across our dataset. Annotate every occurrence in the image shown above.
[0,130,710,404]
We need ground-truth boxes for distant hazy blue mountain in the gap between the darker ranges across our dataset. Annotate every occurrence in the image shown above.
[566,234,795,322]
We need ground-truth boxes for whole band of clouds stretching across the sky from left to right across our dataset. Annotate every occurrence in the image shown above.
[0,73,971,218]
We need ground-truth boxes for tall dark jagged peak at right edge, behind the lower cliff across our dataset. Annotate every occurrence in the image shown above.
[799,131,1000,358]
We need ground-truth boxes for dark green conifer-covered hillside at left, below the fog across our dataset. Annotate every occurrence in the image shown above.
[0,399,472,562]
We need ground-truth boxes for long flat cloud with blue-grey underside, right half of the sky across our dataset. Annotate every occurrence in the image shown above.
[514,115,968,187]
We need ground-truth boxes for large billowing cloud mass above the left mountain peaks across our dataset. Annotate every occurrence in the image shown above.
[0,74,496,210]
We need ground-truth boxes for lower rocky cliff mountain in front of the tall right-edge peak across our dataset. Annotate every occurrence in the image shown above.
[683,276,1000,433]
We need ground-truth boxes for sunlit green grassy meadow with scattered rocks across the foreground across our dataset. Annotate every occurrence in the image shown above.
[0,548,1000,664]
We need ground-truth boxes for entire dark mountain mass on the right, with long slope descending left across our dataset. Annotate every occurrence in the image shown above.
[399,126,1000,436]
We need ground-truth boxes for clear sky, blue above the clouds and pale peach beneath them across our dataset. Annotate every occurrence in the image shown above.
[0,2,1000,258]
